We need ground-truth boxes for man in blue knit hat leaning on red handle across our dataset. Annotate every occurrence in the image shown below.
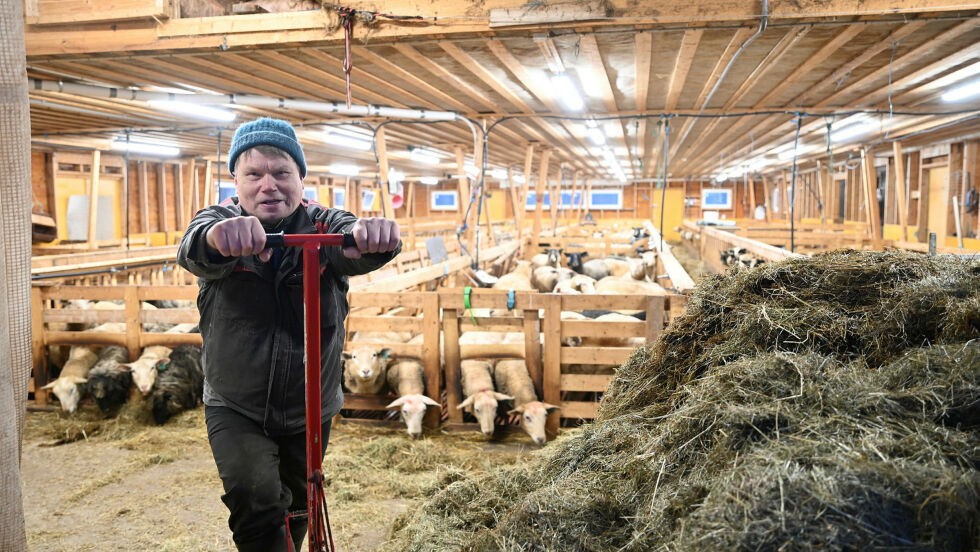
[177,118,401,552]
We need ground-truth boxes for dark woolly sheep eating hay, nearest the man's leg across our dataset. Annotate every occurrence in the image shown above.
[149,345,204,425]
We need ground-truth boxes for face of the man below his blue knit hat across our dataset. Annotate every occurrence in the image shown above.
[235,149,303,224]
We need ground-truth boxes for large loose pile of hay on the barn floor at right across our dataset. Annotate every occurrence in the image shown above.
[389,252,980,551]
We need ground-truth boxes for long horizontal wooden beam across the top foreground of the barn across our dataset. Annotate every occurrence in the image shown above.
[25,0,963,56]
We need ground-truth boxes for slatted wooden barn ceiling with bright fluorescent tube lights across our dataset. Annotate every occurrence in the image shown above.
[25,0,980,182]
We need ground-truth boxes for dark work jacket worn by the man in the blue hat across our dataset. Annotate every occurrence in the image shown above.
[177,197,401,435]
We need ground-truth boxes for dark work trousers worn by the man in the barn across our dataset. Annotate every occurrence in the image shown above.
[204,406,330,552]
